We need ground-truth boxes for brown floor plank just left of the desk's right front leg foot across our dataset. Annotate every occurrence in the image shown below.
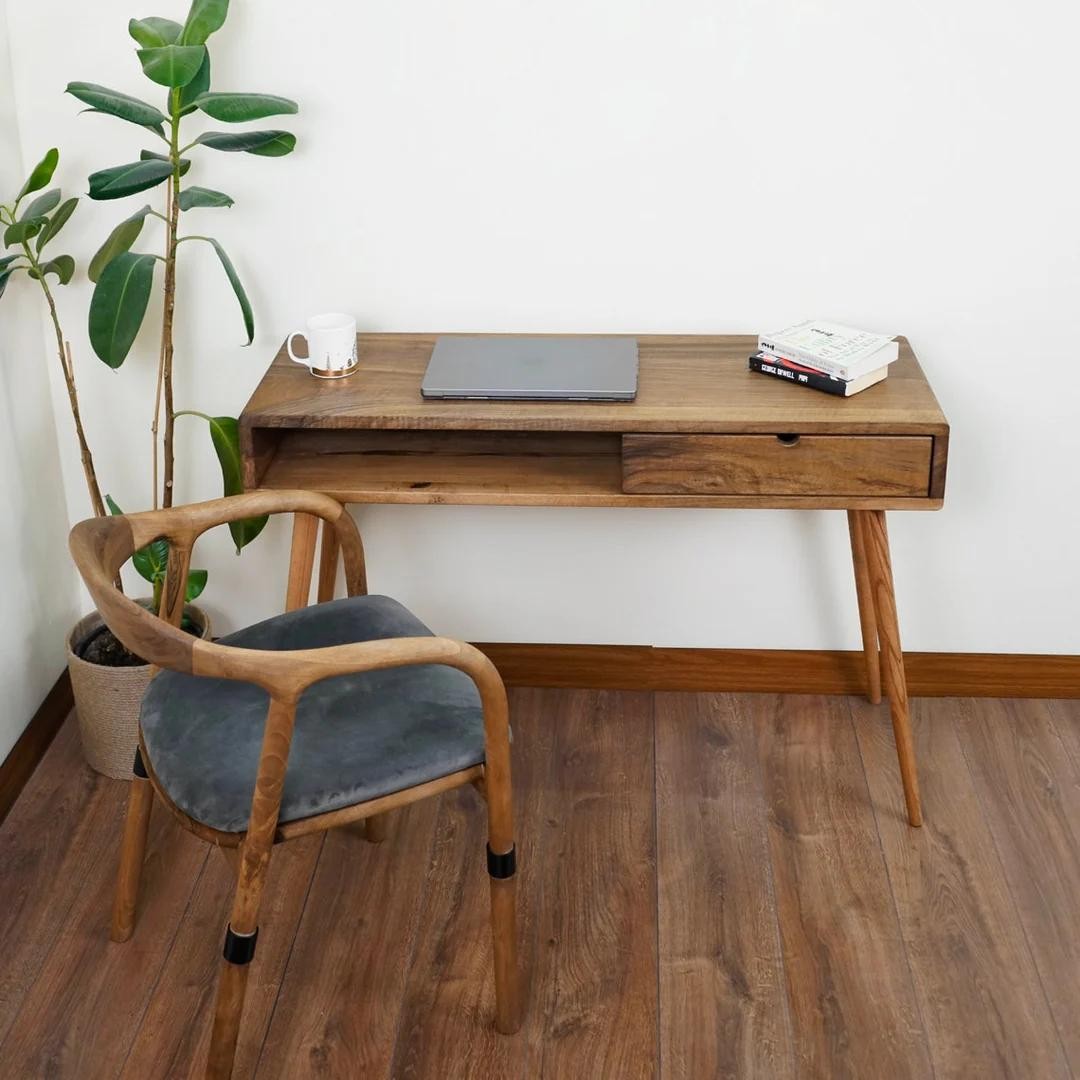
[745,696,931,1080]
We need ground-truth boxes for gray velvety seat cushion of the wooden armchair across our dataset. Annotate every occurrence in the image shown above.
[140,596,484,833]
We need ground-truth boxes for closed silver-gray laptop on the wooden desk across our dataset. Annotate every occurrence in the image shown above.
[420,335,637,402]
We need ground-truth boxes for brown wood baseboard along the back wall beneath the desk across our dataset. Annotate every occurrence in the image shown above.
[477,643,1080,698]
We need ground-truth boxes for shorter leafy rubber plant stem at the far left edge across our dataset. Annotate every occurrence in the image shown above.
[0,147,105,517]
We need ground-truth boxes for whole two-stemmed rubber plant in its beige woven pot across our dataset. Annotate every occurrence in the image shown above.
[0,0,297,779]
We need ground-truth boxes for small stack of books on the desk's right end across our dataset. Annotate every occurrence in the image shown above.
[750,321,900,397]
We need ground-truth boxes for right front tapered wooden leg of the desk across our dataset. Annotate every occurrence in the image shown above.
[854,510,922,826]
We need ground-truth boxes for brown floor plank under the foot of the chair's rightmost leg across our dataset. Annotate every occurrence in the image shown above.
[392,689,566,1080]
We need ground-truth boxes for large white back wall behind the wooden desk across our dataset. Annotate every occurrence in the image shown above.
[2,0,1080,652]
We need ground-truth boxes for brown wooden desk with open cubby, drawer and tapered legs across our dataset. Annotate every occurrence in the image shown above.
[240,334,948,825]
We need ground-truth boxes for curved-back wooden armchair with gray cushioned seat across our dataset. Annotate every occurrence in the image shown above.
[70,491,519,1078]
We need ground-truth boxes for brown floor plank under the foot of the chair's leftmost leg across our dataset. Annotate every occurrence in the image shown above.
[0,794,206,1078]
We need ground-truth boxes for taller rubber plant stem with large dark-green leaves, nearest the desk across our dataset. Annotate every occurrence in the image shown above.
[67,0,297,583]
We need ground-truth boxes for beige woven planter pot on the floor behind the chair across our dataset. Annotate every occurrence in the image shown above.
[67,600,210,780]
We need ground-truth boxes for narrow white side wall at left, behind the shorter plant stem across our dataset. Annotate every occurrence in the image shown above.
[0,0,77,761]
